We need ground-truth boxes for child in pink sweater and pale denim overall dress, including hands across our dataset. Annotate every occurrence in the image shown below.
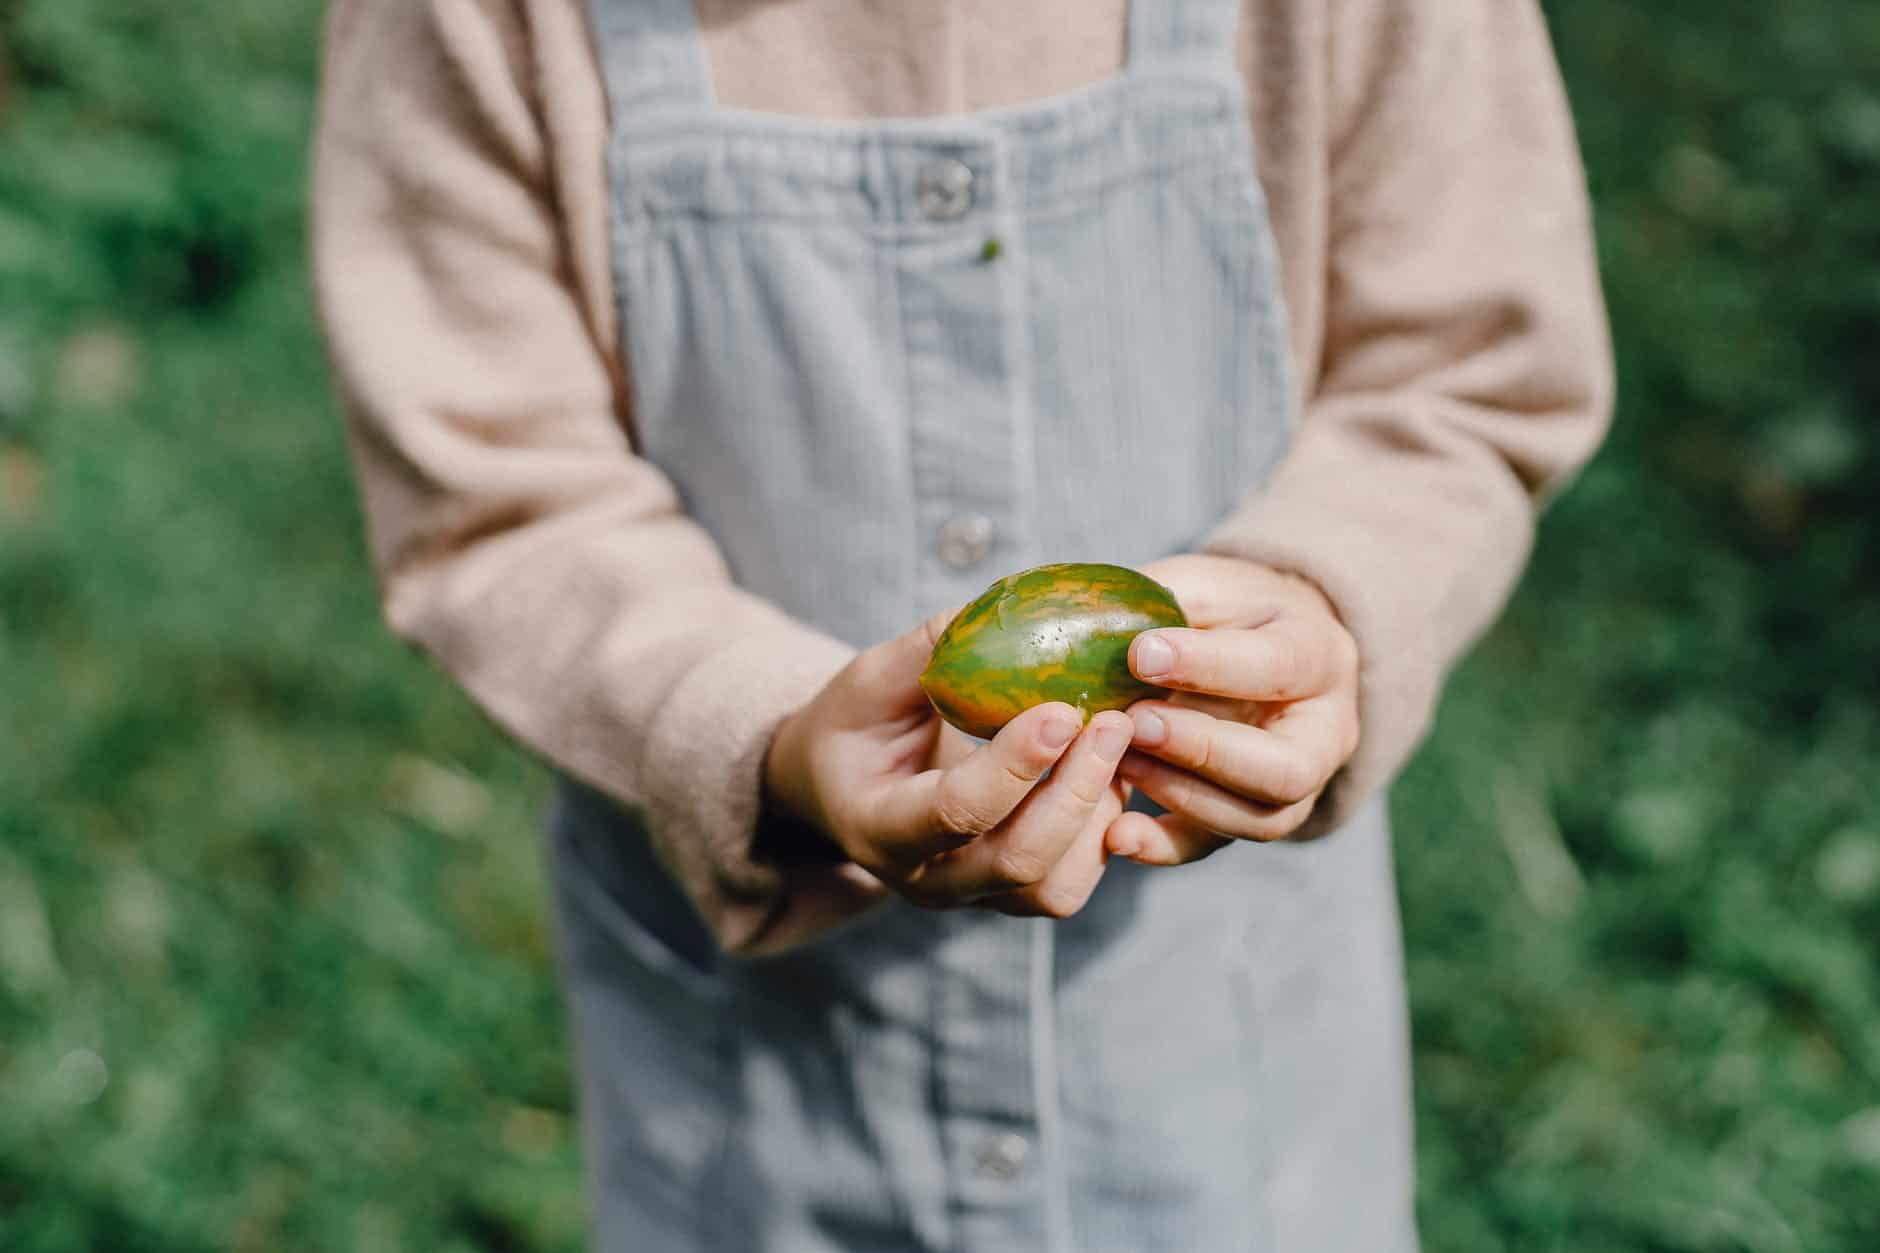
[314,0,1609,1253]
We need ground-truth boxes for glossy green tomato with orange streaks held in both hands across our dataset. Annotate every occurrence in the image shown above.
[921,563,1188,739]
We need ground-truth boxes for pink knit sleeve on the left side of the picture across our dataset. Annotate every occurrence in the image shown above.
[312,0,880,954]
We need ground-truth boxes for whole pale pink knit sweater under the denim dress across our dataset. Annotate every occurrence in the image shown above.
[314,0,1611,952]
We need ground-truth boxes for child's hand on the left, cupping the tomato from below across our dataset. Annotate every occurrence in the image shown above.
[763,613,1132,918]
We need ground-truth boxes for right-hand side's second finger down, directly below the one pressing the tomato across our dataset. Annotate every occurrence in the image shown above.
[1130,700,1346,807]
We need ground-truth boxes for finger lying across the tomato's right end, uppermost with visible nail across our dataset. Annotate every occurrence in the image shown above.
[1130,615,1355,700]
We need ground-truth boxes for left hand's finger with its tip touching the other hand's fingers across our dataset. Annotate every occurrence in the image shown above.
[910,709,1132,899]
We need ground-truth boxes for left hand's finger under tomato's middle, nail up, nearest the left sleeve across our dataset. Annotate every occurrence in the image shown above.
[869,700,1083,867]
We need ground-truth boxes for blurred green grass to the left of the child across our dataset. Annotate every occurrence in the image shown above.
[0,0,581,1253]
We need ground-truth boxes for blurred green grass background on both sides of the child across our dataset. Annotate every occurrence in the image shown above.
[0,0,1880,1253]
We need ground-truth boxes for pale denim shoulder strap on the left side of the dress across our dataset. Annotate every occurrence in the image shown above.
[588,0,713,119]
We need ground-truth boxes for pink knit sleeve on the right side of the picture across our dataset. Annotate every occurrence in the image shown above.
[1203,0,1611,837]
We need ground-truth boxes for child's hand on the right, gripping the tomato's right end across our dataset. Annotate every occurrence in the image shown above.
[1105,555,1357,865]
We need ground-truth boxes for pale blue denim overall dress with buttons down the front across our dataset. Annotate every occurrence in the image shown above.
[551,0,1416,1253]
